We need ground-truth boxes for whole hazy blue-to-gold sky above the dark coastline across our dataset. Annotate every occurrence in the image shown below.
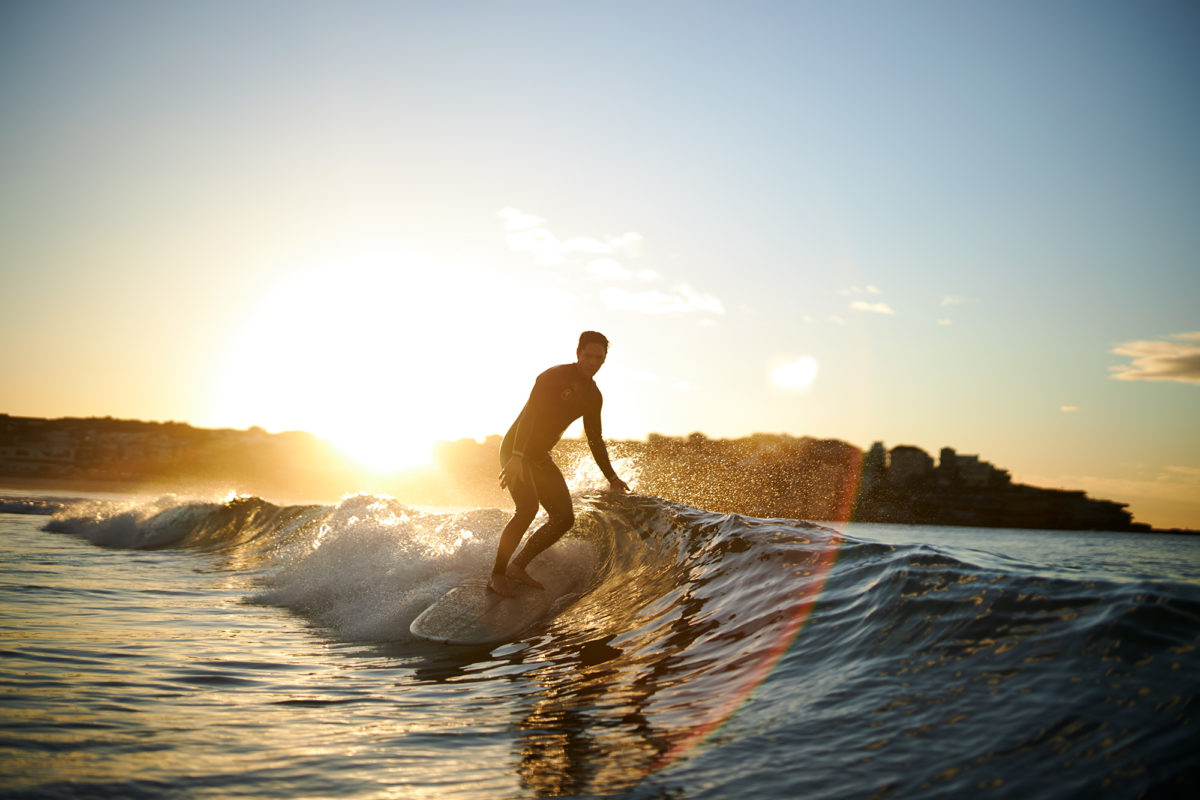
[0,0,1200,528]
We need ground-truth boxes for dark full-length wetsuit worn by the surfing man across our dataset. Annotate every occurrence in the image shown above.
[494,363,617,573]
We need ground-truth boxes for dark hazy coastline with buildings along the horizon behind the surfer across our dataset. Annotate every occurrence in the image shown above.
[0,414,1198,534]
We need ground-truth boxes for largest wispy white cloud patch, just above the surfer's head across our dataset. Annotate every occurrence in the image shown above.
[497,207,725,314]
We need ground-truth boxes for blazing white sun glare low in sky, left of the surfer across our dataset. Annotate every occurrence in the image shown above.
[212,252,504,473]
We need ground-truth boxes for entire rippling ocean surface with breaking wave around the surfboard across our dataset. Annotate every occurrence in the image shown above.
[0,492,1200,800]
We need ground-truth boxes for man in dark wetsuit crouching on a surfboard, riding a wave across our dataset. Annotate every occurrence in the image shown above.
[487,331,629,597]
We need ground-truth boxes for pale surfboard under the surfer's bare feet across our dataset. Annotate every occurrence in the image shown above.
[408,581,556,644]
